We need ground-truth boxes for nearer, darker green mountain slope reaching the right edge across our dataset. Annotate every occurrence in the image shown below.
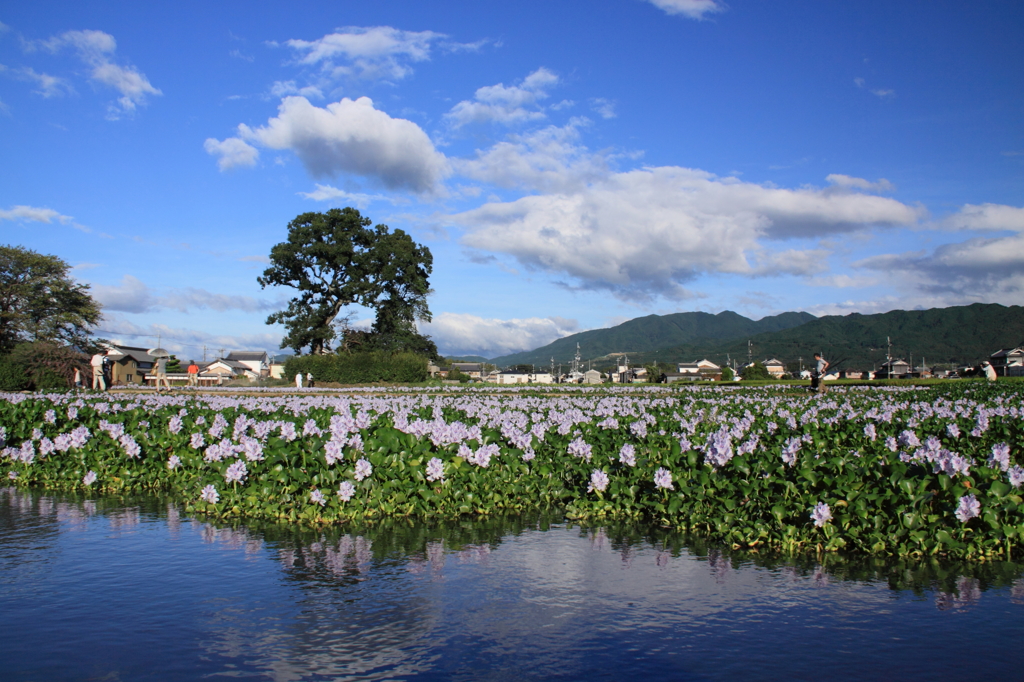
[634,303,1024,370]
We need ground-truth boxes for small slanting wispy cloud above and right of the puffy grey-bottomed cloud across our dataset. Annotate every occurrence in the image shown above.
[444,67,558,128]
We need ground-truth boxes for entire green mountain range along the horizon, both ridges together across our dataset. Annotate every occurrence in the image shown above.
[490,303,1024,370]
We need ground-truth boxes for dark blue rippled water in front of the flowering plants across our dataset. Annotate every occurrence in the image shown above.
[0,488,1024,681]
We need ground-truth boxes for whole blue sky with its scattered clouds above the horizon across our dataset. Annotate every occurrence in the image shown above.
[0,0,1024,357]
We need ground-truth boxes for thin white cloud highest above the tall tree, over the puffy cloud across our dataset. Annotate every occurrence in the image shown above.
[287,26,445,80]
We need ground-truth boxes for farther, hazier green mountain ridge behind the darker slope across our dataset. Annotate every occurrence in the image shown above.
[492,310,815,367]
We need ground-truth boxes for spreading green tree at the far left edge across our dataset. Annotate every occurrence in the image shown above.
[0,246,100,352]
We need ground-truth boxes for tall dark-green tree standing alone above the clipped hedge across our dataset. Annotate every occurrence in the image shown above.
[257,208,436,354]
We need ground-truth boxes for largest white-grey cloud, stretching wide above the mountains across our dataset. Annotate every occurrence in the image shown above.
[452,167,919,300]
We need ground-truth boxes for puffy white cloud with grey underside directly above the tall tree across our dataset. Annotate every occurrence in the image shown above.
[234,96,450,193]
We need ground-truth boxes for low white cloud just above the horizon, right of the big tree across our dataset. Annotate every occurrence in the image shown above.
[420,312,580,357]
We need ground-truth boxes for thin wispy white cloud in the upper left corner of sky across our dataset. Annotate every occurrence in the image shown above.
[40,31,163,119]
